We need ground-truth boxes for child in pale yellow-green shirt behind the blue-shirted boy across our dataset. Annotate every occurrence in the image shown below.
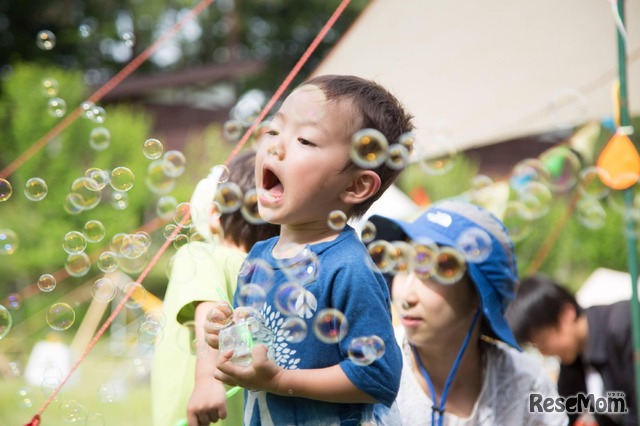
[151,151,279,426]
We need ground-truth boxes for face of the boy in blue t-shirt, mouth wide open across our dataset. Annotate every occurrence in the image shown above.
[256,86,358,226]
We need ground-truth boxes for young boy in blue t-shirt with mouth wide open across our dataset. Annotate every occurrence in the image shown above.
[205,75,413,425]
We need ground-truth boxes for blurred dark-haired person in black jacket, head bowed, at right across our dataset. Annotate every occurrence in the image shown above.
[507,275,637,425]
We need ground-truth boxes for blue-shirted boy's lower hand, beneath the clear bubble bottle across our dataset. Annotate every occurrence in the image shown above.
[214,344,285,393]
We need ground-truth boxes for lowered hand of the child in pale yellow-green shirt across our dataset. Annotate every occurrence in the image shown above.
[187,377,227,426]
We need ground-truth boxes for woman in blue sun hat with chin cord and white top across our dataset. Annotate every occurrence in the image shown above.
[369,200,568,426]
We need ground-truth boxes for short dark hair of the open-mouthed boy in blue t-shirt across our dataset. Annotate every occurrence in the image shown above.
[303,75,414,219]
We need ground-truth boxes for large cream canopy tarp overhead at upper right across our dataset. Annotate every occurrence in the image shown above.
[314,0,640,156]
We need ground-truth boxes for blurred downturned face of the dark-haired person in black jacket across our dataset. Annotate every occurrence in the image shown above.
[529,306,581,364]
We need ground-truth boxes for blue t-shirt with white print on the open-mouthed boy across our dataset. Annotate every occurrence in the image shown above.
[235,226,402,425]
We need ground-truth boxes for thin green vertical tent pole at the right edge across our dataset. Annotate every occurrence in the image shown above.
[617,0,640,424]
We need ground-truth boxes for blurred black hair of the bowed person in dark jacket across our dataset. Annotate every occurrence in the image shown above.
[506,274,583,343]
